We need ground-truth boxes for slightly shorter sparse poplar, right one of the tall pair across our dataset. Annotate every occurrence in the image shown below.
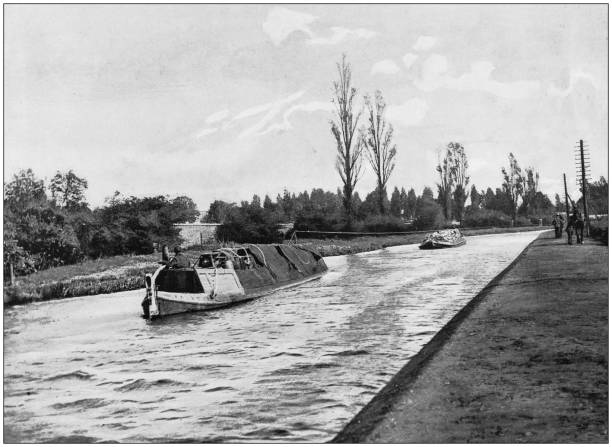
[361,90,397,214]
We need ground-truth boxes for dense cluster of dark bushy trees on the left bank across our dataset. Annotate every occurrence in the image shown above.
[3,169,199,277]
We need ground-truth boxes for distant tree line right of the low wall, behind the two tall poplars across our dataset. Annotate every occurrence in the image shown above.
[202,149,555,242]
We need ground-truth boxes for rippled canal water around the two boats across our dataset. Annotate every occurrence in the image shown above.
[4,232,539,442]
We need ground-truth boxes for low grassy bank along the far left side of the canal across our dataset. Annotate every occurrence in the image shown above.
[3,227,542,306]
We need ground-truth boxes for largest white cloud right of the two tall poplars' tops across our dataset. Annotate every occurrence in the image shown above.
[415,54,540,99]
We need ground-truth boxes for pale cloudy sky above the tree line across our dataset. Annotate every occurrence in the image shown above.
[4,4,608,211]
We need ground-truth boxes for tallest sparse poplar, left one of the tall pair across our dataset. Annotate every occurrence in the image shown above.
[330,55,363,228]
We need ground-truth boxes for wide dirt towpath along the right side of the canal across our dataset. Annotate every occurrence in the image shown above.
[332,232,608,443]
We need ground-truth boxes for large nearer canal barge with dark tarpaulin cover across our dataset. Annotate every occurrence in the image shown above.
[142,244,327,319]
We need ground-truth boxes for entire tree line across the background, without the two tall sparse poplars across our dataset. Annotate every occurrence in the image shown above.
[4,162,608,274]
